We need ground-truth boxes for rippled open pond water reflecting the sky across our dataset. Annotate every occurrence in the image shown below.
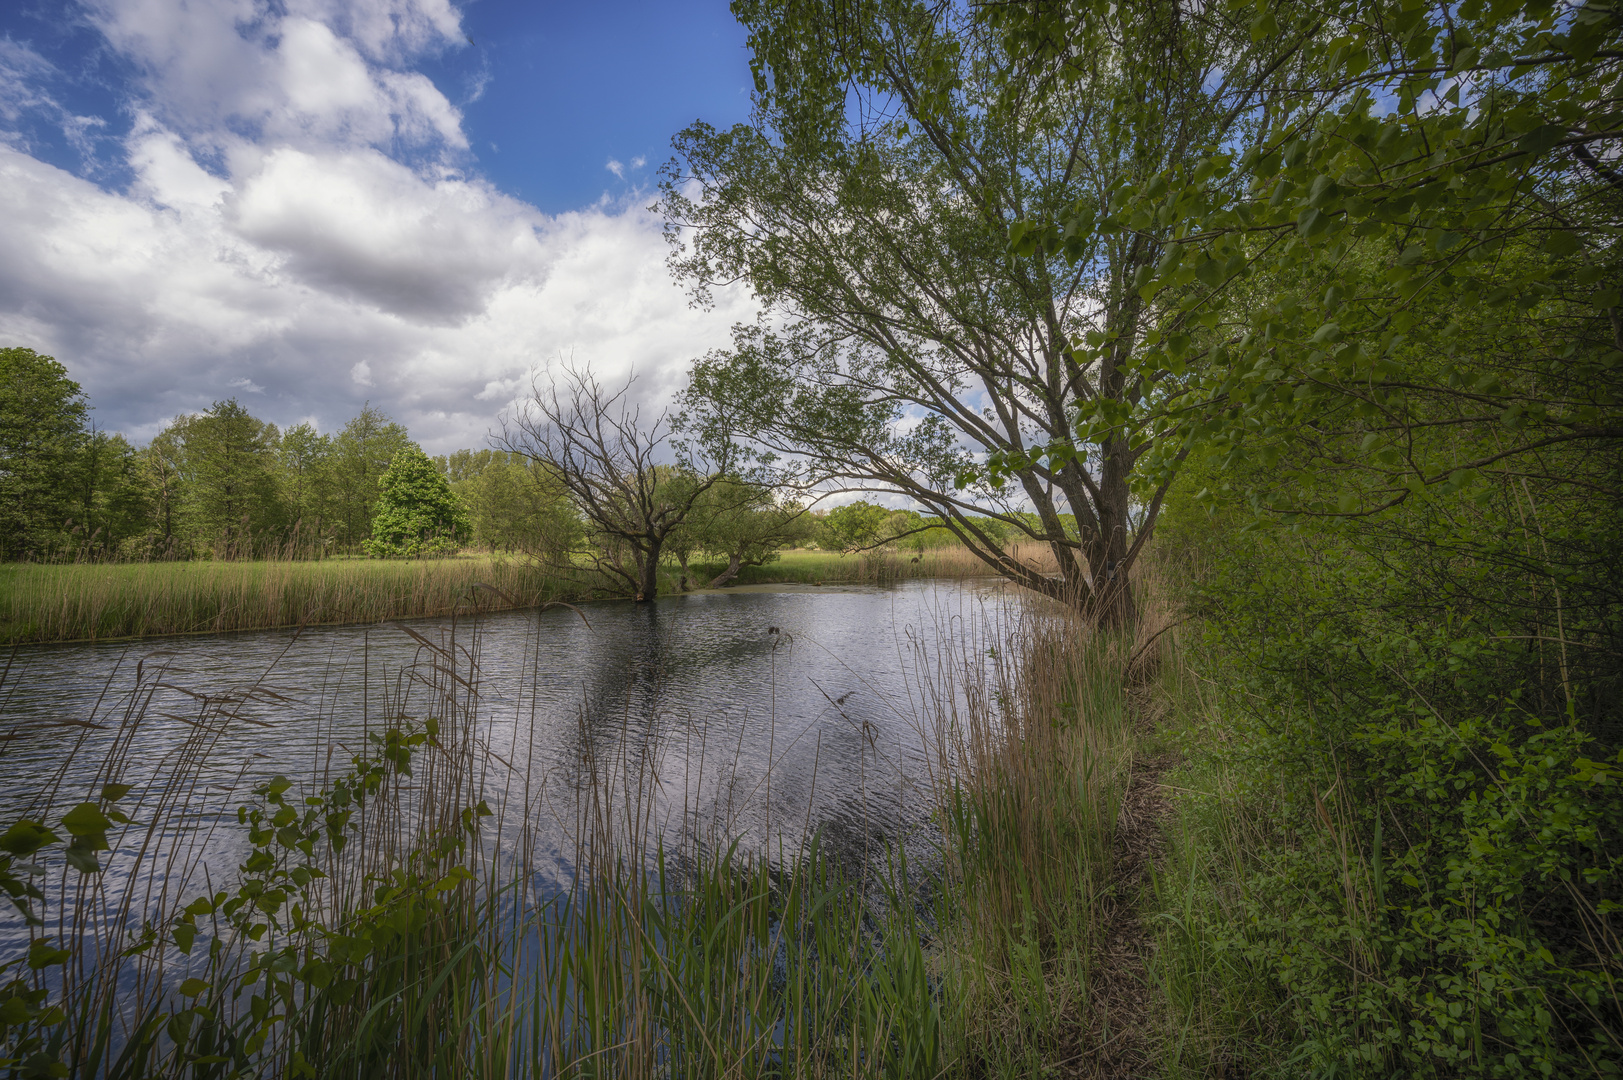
[0,581,1011,902]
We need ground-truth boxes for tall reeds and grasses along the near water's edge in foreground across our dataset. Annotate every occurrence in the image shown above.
[0,565,1175,1080]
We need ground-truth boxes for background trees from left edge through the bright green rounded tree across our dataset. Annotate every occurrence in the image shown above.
[0,348,438,560]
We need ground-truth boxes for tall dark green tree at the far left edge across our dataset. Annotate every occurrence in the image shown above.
[0,348,89,559]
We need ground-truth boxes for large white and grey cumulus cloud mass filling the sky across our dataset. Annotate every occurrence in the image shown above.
[0,0,751,451]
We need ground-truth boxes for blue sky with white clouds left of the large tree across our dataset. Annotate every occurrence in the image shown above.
[0,0,755,453]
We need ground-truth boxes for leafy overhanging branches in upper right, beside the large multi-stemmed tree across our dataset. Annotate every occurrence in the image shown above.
[1005,0,1623,513]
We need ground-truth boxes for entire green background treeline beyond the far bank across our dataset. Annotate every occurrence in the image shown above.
[0,348,1014,580]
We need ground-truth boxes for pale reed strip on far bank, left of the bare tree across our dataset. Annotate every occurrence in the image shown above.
[0,555,588,643]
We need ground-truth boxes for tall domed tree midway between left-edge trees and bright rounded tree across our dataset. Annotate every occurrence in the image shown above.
[175,398,287,559]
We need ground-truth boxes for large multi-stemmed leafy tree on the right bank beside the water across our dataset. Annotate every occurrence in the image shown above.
[661,0,1290,622]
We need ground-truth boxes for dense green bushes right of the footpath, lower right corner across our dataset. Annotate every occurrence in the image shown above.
[1167,460,1623,1077]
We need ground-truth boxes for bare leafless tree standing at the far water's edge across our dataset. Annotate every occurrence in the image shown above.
[497,367,735,601]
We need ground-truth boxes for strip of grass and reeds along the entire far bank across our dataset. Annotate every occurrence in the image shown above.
[0,546,1052,645]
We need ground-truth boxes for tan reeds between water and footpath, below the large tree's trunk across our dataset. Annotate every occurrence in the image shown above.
[902,549,1177,1072]
